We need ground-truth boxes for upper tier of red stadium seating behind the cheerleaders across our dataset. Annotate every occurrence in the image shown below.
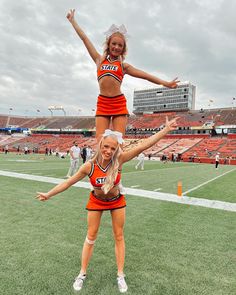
[0,108,236,129]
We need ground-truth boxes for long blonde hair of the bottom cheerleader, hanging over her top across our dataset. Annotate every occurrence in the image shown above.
[92,135,121,195]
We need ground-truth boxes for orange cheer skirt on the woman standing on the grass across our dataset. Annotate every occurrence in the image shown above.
[86,192,126,211]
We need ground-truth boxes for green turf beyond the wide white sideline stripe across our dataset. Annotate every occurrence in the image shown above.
[0,154,236,203]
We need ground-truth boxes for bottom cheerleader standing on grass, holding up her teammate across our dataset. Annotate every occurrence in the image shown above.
[36,119,176,293]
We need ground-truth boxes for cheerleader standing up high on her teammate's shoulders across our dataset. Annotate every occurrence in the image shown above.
[67,9,179,141]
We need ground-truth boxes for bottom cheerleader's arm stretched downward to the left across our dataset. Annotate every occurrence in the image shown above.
[36,162,91,201]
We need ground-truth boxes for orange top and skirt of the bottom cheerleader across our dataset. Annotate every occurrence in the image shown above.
[86,161,126,211]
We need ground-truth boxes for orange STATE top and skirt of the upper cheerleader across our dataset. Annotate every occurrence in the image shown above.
[96,56,129,116]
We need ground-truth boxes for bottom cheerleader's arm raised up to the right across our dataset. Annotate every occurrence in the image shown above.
[119,117,178,164]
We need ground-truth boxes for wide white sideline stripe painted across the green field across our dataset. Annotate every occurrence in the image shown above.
[0,170,236,212]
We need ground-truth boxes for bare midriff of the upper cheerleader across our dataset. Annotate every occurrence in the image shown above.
[99,76,122,97]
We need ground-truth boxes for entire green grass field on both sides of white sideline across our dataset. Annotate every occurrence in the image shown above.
[0,154,236,295]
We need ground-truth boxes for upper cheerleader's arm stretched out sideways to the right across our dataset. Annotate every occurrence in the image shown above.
[124,63,180,88]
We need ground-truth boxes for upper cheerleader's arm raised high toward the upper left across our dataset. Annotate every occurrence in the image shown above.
[66,9,101,64]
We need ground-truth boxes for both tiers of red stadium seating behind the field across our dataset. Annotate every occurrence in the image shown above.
[0,108,236,161]
